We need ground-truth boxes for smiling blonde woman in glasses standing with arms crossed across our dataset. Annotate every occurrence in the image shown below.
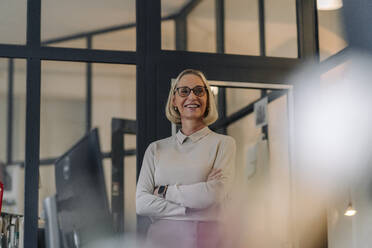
[136,69,236,248]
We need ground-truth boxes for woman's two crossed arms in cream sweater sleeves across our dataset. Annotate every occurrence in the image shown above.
[136,137,236,217]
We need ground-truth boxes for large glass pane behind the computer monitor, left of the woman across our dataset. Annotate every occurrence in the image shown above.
[39,61,136,232]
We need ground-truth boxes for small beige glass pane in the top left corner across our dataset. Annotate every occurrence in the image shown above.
[0,0,27,44]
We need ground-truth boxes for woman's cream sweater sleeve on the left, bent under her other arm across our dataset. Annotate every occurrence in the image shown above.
[136,143,186,217]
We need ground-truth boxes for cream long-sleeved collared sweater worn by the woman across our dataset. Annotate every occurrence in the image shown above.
[136,127,236,220]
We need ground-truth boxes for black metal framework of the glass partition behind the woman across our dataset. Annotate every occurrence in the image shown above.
[0,0,319,247]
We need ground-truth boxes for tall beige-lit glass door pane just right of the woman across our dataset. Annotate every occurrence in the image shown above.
[227,89,292,247]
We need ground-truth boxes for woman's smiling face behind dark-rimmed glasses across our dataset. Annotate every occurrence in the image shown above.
[173,74,208,120]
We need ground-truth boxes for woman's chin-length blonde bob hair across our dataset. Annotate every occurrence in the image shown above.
[165,69,218,126]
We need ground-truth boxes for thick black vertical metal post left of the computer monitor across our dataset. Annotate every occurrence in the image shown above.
[24,0,41,247]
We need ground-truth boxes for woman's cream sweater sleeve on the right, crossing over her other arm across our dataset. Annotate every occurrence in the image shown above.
[166,136,236,209]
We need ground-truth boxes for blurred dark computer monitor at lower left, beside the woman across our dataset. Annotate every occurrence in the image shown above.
[55,129,112,248]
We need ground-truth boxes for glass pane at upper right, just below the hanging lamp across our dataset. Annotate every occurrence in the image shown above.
[318,8,347,60]
